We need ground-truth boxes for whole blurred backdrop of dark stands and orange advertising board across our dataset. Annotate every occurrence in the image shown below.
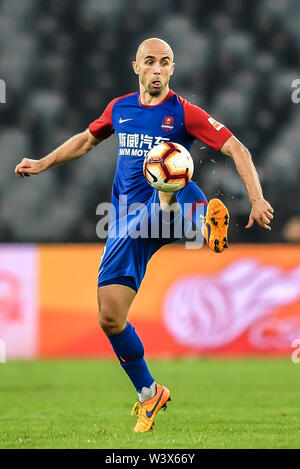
[0,0,300,357]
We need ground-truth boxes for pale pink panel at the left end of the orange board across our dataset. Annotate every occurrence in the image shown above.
[0,245,38,359]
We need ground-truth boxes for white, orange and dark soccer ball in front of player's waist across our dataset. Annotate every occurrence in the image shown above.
[143,142,194,192]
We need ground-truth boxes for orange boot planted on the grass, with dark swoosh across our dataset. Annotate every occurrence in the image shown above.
[131,384,171,433]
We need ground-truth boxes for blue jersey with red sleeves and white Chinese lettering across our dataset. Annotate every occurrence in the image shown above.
[89,90,232,205]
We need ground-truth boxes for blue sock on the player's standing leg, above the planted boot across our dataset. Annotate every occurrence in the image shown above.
[108,322,154,392]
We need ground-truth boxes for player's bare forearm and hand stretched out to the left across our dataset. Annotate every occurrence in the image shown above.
[15,129,101,178]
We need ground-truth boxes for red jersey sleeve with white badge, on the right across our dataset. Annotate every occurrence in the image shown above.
[182,99,232,151]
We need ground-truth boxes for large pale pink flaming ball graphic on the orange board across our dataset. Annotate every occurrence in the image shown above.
[163,259,300,349]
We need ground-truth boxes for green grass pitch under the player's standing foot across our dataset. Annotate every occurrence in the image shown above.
[0,358,300,449]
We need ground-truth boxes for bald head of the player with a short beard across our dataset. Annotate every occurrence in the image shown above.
[132,38,175,96]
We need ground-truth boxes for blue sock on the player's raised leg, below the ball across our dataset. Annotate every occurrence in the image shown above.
[174,181,207,230]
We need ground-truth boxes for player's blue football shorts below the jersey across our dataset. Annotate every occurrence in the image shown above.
[98,182,205,291]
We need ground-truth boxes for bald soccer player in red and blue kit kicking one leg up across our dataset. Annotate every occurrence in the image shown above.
[15,38,273,432]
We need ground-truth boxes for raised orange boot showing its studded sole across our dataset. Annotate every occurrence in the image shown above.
[203,199,229,252]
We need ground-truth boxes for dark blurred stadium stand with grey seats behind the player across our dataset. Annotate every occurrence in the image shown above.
[0,0,300,242]
